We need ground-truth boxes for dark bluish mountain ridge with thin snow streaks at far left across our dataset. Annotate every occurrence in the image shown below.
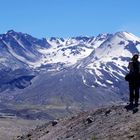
[0,30,49,70]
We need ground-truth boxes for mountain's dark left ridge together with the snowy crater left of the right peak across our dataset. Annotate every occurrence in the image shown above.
[0,30,109,69]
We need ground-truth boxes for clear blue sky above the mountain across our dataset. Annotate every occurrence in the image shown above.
[0,0,140,38]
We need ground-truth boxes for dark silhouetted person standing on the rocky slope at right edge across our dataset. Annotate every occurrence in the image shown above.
[128,54,140,107]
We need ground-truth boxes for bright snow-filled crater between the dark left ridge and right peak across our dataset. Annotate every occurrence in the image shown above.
[39,35,109,66]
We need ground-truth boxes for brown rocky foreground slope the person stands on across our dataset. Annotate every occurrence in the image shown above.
[18,105,140,140]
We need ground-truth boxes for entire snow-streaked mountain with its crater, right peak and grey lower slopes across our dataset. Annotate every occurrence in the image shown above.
[0,31,140,108]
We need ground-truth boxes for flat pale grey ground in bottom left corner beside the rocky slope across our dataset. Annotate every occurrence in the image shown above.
[0,118,45,140]
